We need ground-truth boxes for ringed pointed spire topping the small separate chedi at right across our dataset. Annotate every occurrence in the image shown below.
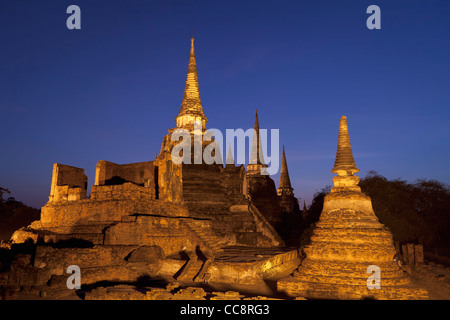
[331,116,359,176]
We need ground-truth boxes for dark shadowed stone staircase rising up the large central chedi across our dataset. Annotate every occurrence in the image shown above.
[183,165,283,248]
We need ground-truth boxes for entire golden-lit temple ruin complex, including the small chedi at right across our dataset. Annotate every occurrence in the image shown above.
[0,39,426,299]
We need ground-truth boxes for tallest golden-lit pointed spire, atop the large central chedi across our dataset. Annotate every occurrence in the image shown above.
[175,38,207,127]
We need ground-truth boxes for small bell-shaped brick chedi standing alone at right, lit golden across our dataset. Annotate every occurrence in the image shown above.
[278,116,427,299]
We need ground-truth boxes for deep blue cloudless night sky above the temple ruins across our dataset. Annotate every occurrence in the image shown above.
[0,0,450,207]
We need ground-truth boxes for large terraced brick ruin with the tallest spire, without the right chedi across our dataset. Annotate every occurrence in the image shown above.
[0,39,298,296]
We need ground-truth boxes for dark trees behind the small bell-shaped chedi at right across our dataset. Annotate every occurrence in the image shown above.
[305,171,450,246]
